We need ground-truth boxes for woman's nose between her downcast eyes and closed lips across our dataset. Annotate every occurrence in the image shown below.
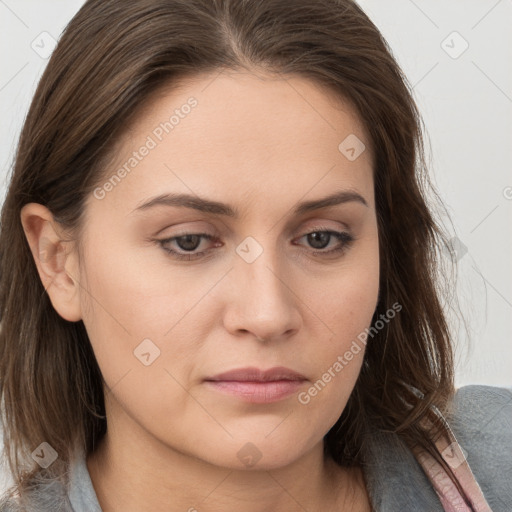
[224,244,304,342]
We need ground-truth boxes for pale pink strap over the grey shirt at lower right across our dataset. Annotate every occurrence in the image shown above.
[413,406,492,512]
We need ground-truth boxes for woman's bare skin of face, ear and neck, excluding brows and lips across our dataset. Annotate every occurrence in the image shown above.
[21,71,379,512]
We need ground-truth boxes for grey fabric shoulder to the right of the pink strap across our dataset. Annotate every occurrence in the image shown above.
[446,385,512,511]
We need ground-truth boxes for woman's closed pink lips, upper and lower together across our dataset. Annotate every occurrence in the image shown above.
[204,366,307,404]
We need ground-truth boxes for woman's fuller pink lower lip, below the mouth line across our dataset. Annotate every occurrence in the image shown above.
[205,380,305,404]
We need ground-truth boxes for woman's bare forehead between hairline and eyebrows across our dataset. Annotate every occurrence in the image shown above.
[92,71,373,213]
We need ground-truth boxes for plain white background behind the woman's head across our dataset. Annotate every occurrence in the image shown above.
[0,0,512,492]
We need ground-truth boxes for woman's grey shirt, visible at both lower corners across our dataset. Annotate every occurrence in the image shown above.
[0,386,512,512]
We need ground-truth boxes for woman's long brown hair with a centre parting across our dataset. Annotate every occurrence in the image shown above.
[0,0,464,504]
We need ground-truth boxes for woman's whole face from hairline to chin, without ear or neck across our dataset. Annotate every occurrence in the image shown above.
[77,72,379,468]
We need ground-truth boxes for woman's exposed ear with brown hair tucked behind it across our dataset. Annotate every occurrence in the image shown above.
[21,203,82,322]
